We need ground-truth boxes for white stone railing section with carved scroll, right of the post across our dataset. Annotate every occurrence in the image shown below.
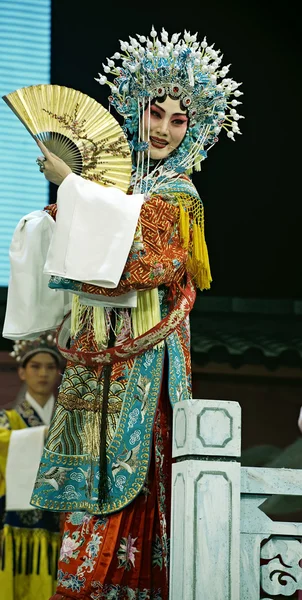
[240,468,302,600]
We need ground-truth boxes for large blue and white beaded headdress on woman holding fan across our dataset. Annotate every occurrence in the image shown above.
[96,27,243,188]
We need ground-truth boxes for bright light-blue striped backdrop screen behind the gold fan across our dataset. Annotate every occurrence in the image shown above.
[0,0,51,286]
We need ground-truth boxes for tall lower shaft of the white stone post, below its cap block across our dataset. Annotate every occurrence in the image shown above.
[170,460,240,600]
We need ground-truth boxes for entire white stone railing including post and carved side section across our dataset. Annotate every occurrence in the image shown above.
[170,400,302,600]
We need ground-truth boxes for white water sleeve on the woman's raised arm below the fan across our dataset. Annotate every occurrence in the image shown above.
[44,173,144,288]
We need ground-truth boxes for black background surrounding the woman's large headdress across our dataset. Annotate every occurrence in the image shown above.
[51,0,302,298]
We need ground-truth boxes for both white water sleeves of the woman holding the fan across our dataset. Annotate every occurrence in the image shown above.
[3,173,144,340]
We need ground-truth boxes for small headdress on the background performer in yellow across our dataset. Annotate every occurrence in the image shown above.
[10,331,63,367]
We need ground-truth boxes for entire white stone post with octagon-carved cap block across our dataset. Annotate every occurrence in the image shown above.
[170,400,241,600]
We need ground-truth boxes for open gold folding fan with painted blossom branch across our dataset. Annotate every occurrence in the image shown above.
[3,84,131,192]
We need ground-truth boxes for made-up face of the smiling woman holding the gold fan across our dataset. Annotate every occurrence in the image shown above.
[143,96,188,160]
